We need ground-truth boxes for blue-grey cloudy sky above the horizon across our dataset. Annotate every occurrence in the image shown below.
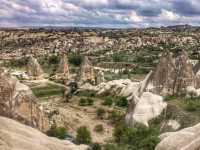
[0,0,200,28]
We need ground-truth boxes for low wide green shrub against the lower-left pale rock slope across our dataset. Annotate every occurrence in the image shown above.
[47,126,67,139]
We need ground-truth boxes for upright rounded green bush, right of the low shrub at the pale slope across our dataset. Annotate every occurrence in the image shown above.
[76,126,92,144]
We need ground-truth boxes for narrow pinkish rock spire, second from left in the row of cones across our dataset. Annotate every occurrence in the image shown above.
[57,54,69,79]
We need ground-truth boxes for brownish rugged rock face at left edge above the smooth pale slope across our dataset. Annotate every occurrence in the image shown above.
[0,75,48,130]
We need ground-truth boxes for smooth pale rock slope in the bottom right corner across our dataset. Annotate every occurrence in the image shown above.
[155,124,200,150]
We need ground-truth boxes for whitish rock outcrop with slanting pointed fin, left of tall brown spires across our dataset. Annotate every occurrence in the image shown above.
[96,72,167,126]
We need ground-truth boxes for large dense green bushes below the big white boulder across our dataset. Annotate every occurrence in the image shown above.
[113,124,159,150]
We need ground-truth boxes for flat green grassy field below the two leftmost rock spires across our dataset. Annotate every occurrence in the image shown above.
[32,84,64,97]
